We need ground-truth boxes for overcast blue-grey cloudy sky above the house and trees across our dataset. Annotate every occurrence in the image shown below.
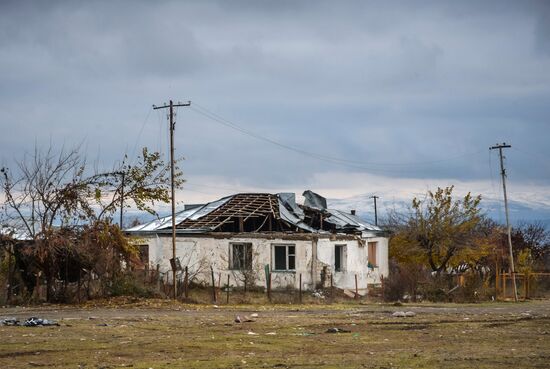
[0,0,550,217]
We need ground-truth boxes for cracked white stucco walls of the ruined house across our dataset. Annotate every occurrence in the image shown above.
[142,235,388,293]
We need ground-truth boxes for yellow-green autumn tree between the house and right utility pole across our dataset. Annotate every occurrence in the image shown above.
[390,186,493,273]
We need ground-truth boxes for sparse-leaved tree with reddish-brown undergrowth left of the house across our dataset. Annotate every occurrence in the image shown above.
[0,147,183,300]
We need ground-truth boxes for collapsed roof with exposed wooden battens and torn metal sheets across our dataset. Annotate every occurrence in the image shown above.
[126,191,382,234]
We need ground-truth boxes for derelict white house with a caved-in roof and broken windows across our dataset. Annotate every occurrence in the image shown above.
[126,191,388,294]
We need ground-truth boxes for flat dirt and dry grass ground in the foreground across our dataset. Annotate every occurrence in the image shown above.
[0,300,550,369]
